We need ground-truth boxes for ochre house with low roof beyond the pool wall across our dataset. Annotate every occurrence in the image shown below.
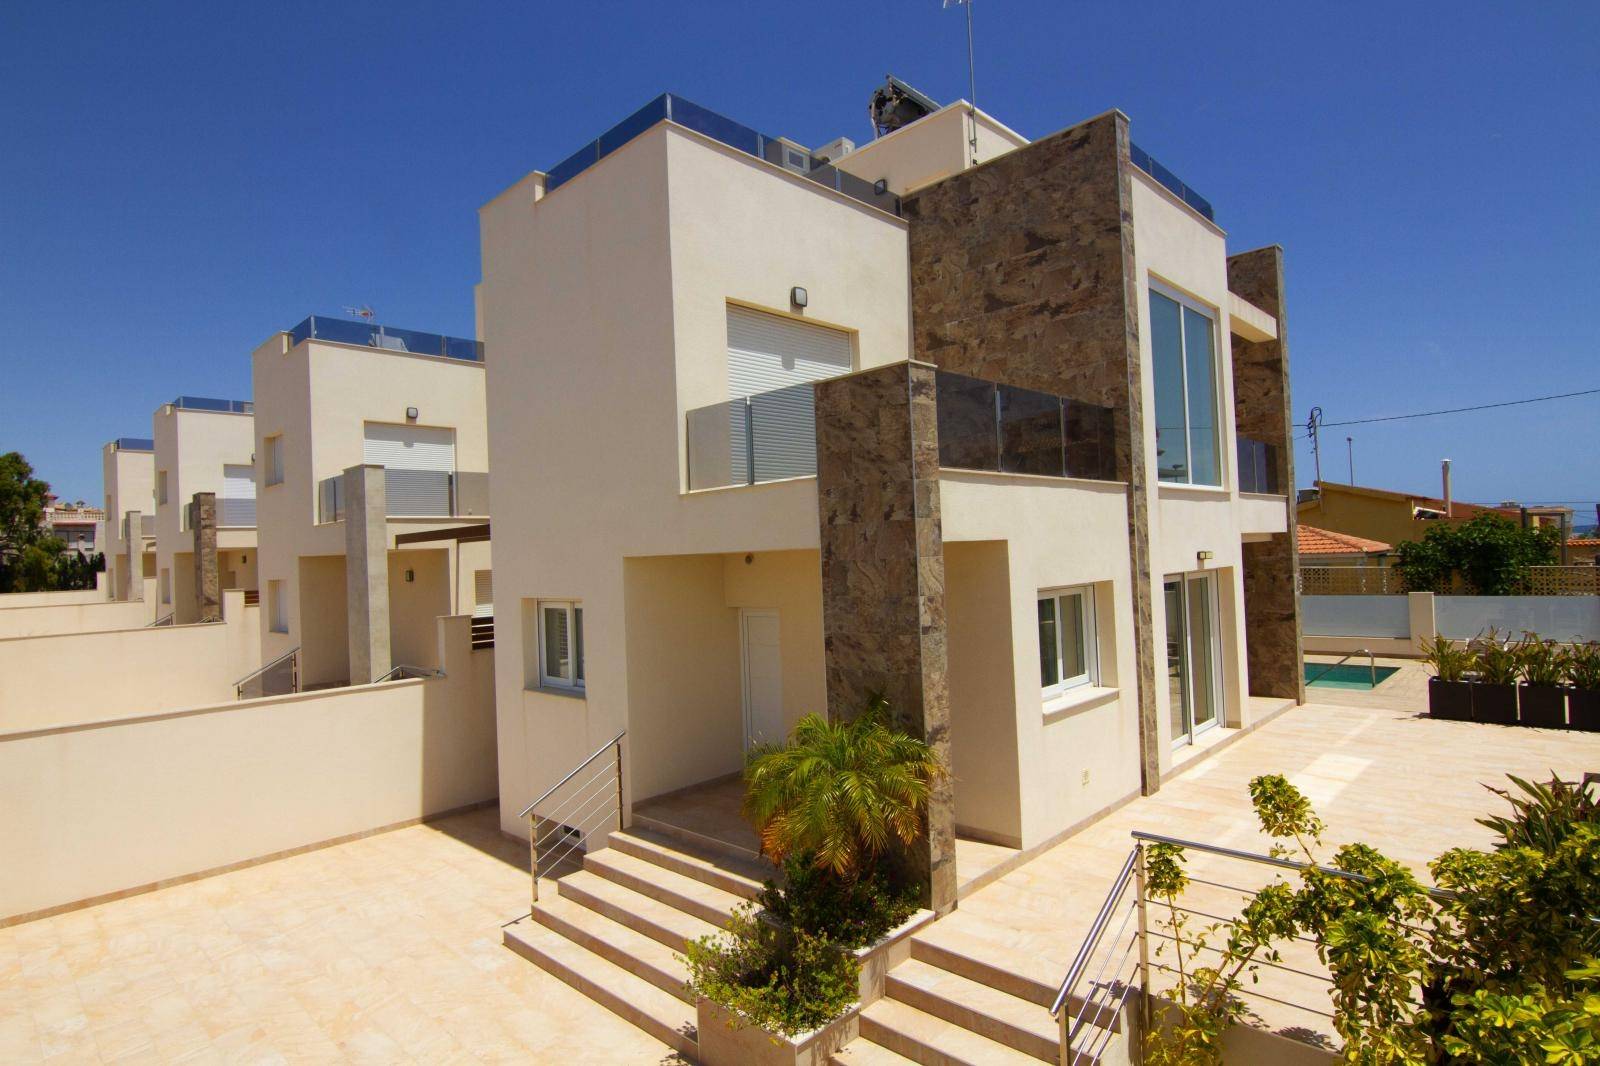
[1296,482,1573,544]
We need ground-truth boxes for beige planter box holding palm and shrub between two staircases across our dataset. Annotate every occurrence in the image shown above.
[696,911,934,1066]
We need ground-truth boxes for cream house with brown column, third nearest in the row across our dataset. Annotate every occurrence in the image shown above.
[154,395,258,624]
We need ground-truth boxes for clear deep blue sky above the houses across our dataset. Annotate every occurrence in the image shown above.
[0,0,1600,520]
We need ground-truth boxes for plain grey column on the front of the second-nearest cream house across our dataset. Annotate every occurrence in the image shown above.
[344,466,392,685]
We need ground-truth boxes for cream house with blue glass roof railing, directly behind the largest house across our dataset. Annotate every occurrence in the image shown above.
[251,317,493,687]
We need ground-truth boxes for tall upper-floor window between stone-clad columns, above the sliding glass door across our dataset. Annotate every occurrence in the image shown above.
[1150,283,1222,485]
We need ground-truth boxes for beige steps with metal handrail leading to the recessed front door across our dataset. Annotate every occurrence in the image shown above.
[504,820,771,1060]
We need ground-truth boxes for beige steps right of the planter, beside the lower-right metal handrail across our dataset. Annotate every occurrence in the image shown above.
[830,935,1133,1066]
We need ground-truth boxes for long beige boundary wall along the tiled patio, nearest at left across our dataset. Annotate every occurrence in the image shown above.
[0,618,496,922]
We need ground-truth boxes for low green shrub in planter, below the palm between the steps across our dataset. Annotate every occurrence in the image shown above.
[683,903,861,1037]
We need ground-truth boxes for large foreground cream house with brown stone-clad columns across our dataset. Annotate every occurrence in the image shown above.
[476,96,1302,908]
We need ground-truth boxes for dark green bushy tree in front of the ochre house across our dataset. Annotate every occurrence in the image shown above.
[1395,511,1562,595]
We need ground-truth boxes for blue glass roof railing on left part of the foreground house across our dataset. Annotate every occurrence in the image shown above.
[544,93,901,214]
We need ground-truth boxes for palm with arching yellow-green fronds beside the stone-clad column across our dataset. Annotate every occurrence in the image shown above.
[744,696,946,880]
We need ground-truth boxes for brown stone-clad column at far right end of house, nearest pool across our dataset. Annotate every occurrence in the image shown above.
[1227,245,1306,703]
